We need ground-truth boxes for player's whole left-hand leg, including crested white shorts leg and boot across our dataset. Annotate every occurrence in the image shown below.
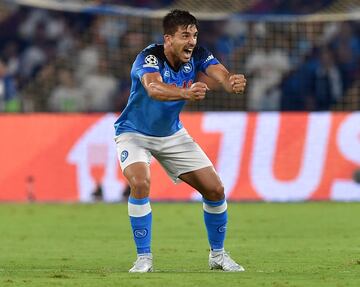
[116,134,153,272]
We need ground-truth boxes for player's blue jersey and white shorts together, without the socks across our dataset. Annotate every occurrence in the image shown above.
[115,44,219,182]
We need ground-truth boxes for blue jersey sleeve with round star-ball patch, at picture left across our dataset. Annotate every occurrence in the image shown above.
[133,51,161,79]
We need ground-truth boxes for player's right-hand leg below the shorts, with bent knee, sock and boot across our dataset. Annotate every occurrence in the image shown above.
[179,166,244,272]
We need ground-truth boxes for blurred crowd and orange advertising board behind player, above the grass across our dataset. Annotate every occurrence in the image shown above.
[0,0,360,202]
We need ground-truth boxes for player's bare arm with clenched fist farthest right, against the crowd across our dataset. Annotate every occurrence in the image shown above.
[202,64,246,94]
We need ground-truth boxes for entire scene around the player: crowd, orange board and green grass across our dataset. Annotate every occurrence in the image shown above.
[0,3,360,287]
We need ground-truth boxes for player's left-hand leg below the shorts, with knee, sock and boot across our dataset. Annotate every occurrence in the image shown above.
[124,162,152,272]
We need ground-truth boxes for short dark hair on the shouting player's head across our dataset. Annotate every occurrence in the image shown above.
[163,9,199,35]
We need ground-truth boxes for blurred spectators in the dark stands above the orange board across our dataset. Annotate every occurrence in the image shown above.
[0,0,360,112]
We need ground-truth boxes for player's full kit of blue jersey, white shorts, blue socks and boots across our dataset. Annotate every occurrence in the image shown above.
[115,45,238,272]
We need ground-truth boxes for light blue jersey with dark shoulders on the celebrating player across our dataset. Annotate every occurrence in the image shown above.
[115,44,219,137]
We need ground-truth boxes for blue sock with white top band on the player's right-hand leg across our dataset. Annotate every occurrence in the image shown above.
[203,198,228,251]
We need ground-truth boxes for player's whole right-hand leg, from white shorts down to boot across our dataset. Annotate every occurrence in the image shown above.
[153,129,243,271]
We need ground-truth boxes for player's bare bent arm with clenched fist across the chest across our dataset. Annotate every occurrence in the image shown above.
[141,72,209,101]
